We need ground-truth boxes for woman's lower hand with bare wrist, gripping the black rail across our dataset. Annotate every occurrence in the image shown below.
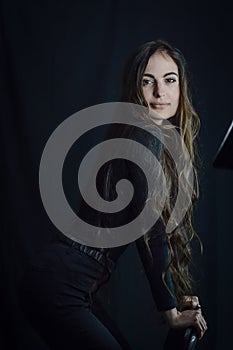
[164,308,207,339]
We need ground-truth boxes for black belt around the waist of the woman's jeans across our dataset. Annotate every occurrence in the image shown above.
[59,235,115,271]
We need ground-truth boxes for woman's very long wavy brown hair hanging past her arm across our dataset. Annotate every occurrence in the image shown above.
[121,40,200,305]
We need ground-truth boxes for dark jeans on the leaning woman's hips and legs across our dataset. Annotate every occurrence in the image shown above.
[20,242,129,350]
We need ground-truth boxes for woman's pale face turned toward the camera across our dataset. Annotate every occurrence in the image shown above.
[142,52,180,124]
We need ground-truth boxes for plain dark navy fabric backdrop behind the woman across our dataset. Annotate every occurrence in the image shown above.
[0,0,233,350]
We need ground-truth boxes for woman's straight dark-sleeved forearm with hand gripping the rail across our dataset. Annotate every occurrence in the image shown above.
[136,231,207,339]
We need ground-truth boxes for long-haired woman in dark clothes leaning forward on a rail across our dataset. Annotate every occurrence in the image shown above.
[21,41,207,350]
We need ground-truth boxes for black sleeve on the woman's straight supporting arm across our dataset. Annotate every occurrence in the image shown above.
[125,125,177,311]
